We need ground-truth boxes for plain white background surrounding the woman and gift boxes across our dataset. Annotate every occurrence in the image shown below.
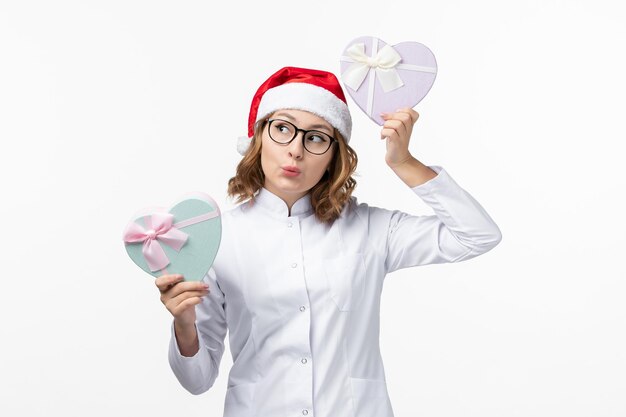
[0,0,626,417]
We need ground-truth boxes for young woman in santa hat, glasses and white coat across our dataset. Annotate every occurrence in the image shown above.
[156,67,501,417]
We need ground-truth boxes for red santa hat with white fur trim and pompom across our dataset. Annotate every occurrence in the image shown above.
[237,67,352,155]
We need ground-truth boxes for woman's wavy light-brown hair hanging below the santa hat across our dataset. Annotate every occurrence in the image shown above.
[228,119,358,224]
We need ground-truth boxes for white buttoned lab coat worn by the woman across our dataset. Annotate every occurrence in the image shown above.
[169,166,501,417]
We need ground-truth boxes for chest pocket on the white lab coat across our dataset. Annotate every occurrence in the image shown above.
[324,253,365,311]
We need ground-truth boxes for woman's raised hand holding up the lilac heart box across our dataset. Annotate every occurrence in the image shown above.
[380,108,419,169]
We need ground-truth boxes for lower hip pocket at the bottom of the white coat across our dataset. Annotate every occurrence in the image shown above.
[350,378,393,417]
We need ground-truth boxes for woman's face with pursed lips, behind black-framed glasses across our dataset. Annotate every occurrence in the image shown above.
[261,110,335,207]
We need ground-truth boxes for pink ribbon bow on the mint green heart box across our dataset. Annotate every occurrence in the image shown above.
[124,213,188,272]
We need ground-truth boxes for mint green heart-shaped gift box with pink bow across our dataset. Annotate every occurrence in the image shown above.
[123,192,222,281]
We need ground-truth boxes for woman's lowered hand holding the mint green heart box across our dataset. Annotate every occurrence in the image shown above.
[155,274,210,328]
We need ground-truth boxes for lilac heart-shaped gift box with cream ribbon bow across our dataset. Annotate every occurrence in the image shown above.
[340,36,437,126]
